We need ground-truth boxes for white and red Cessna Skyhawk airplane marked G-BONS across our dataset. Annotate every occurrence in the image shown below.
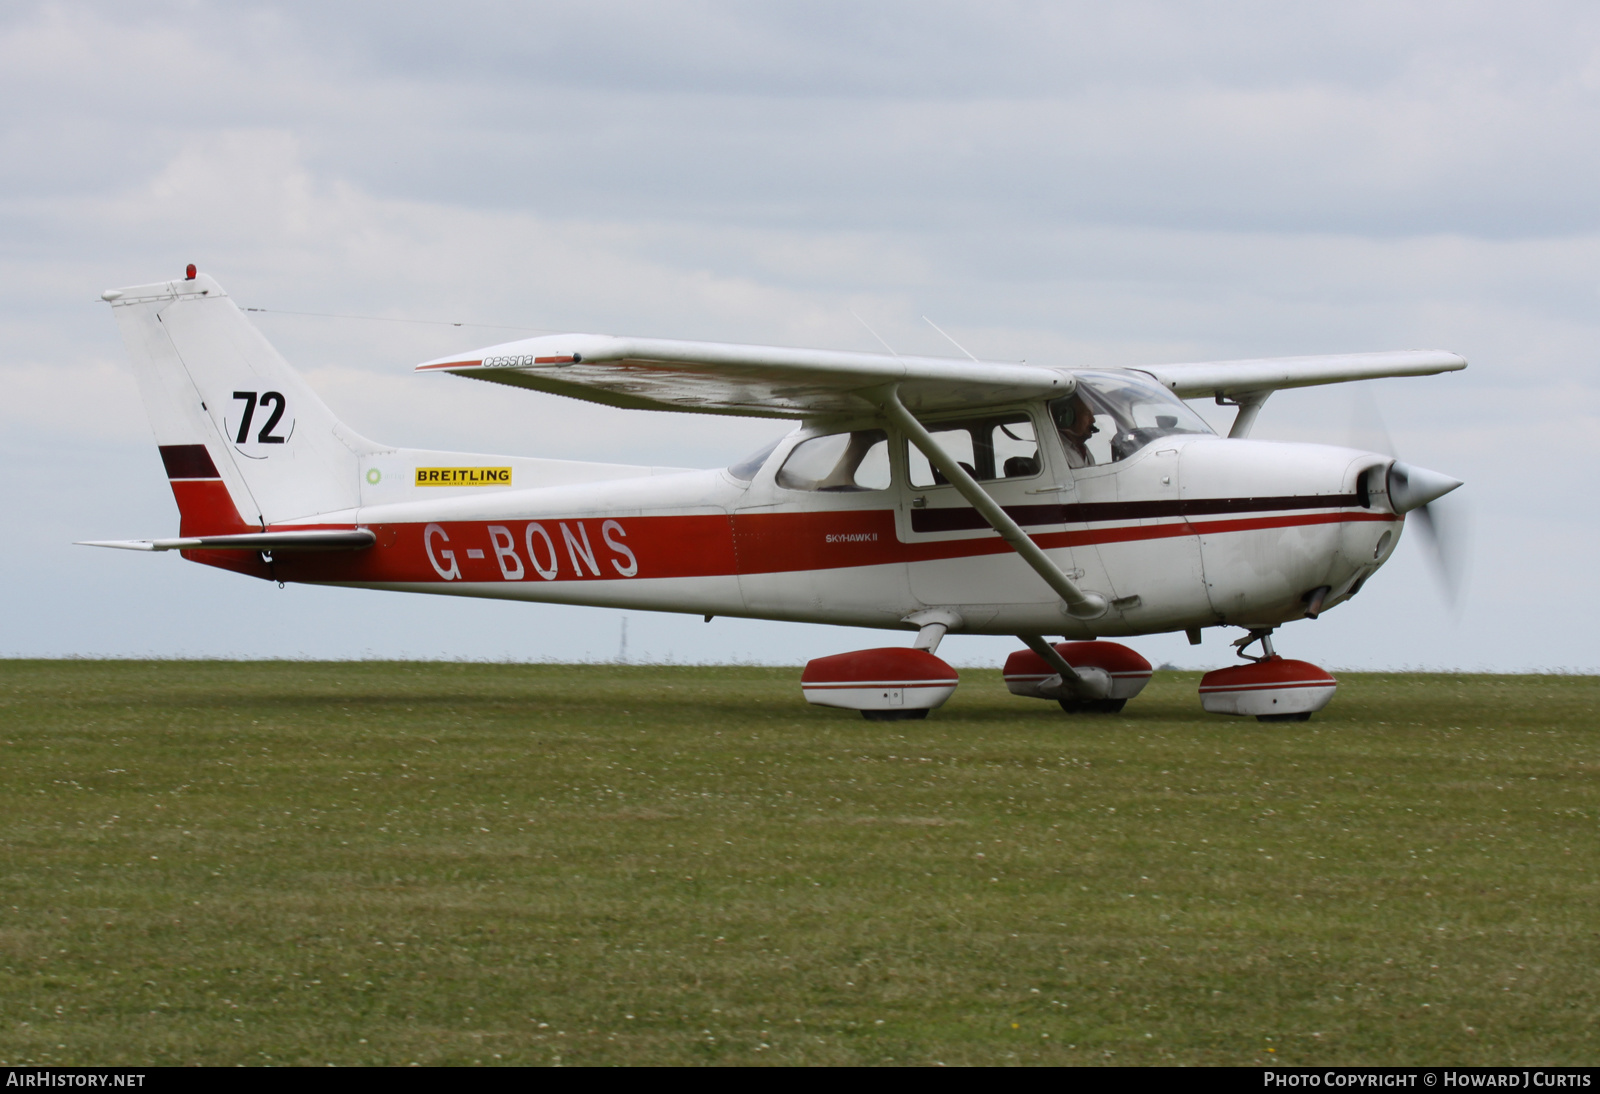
[84,266,1466,720]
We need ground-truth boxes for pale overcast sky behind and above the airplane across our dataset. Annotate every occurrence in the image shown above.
[0,0,1600,672]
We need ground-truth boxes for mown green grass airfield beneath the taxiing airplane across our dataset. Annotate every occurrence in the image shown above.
[0,661,1600,1064]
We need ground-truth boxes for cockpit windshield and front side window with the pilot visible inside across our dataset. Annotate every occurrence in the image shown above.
[1050,373,1211,467]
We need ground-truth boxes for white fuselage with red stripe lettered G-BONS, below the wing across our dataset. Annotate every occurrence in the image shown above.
[174,429,1403,638]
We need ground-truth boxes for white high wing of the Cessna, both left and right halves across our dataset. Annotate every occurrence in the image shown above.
[418,334,1467,417]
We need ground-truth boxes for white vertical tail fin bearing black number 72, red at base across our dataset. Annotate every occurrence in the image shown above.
[104,267,379,536]
